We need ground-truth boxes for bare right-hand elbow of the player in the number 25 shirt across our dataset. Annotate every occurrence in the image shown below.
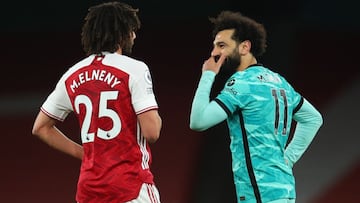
[137,109,162,143]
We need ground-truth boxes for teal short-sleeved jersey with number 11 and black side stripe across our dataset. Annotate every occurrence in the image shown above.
[215,65,303,203]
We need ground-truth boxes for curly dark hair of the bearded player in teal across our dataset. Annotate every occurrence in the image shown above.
[209,11,266,57]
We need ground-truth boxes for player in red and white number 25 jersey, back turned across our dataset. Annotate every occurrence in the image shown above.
[32,2,162,203]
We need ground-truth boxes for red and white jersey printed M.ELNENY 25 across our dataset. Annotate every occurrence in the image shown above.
[41,53,158,202]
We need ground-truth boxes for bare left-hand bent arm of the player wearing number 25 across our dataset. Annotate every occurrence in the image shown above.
[32,111,83,159]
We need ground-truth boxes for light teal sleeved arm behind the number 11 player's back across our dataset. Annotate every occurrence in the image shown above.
[285,99,323,166]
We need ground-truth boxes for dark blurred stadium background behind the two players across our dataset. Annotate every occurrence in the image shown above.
[0,0,360,203]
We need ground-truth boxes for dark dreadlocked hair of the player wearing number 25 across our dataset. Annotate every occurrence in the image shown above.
[81,2,141,55]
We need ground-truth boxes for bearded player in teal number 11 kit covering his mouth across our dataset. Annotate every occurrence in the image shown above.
[190,11,323,203]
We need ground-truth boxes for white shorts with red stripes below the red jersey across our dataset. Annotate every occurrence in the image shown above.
[126,183,160,203]
